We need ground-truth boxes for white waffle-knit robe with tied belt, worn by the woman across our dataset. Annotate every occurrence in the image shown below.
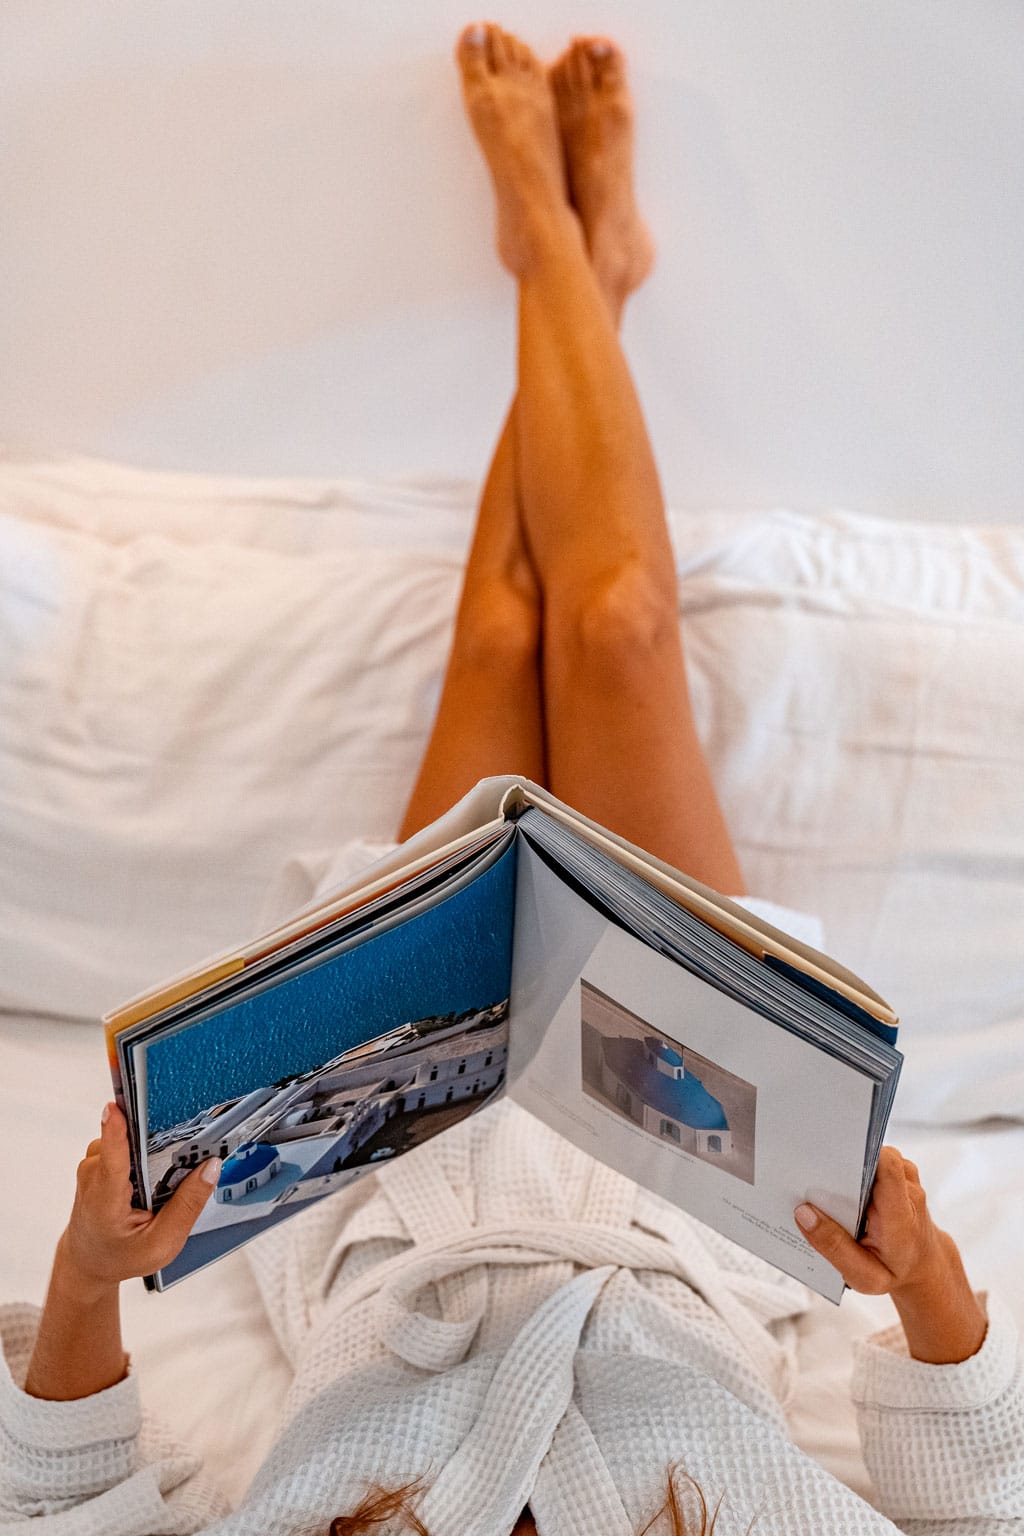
[0,866,1024,1536]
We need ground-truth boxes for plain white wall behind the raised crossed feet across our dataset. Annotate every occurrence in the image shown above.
[0,0,1024,521]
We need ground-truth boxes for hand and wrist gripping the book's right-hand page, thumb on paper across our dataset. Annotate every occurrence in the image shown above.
[794,1147,987,1364]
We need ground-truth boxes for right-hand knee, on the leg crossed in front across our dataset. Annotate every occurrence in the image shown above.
[548,568,679,671]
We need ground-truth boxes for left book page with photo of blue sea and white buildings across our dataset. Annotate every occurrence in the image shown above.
[132,843,517,1290]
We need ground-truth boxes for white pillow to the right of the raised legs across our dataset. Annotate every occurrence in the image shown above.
[676,511,1024,1121]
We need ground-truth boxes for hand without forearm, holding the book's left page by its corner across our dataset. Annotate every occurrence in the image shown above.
[58,1104,221,1290]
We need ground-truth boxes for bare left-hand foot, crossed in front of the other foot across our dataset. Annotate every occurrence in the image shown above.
[456,22,571,275]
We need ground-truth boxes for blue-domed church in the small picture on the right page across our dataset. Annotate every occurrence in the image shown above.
[602,1035,732,1160]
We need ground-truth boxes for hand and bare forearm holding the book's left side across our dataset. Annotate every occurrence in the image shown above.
[25,1104,220,1402]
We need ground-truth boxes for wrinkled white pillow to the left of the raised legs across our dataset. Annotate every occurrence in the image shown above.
[0,462,468,1018]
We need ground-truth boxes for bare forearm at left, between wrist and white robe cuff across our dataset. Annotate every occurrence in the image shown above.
[25,1238,127,1402]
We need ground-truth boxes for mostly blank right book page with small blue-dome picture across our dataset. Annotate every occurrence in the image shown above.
[508,845,874,1301]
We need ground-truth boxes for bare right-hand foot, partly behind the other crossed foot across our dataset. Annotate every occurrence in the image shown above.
[551,37,654,312]
